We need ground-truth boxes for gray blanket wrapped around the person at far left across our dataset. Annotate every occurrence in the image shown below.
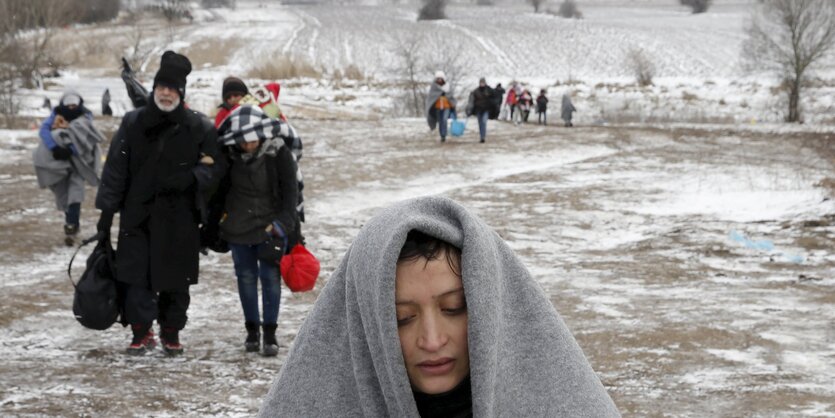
[32,117,104,188]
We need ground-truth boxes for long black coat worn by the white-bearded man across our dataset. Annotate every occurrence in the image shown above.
[96,98,218,291]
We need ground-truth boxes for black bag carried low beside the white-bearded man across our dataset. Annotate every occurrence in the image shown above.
[67,234,124,330]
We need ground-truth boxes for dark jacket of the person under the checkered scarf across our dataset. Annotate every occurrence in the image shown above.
[212,138,299,251]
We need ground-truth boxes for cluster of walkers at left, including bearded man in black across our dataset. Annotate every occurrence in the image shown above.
[34,51,303,356]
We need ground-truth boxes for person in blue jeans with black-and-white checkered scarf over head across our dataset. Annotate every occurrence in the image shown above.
[204,105,299,356]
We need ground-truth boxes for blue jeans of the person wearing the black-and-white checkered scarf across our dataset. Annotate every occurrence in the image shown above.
[229,242,281,324]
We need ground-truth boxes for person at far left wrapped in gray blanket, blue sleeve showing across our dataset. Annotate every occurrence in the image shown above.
[32,90,104,246]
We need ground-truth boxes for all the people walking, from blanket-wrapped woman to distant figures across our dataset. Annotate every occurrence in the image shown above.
[27,51,619,417]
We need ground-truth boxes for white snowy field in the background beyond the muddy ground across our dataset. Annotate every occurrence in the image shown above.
[14,0,835,125]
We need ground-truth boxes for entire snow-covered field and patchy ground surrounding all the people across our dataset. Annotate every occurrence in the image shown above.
[0,0,835,417]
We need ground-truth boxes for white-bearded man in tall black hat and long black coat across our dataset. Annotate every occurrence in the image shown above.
[96,51,218,355]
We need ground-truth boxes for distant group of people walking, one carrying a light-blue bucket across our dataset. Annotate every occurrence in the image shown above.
[425,76,577,143]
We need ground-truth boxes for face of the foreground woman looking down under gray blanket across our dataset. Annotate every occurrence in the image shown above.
[395,254,470,394]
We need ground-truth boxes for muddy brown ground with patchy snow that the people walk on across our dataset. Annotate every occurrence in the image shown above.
[0,120,835,417]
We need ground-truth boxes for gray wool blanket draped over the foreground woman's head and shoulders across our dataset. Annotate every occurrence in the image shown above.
[259,197,620,418]
